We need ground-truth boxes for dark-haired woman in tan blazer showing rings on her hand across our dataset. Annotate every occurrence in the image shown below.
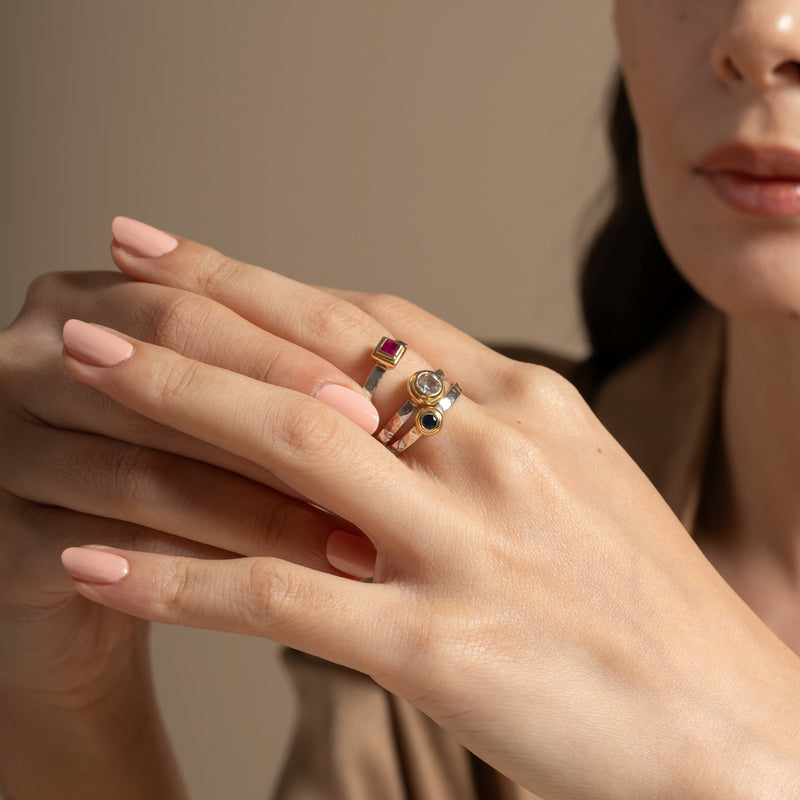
[2,0,800,798]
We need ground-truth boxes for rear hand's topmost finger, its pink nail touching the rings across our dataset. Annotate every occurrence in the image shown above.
[18,273,378,433]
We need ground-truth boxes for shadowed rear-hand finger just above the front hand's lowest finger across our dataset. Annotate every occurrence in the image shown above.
[4,427,354,570]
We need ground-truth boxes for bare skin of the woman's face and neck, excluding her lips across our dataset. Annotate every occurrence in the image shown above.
[615,0,800,650]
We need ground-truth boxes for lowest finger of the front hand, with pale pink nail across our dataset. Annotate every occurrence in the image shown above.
[62,547,400,674]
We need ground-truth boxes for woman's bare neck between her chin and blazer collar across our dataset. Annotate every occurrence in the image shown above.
[709,312,800,583]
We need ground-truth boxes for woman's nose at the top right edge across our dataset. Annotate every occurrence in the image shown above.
[711,0,800,89]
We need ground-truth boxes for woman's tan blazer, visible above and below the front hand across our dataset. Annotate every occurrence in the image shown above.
[275,305,723,800]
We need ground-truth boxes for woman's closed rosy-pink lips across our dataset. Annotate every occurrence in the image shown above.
[695,143,800,218]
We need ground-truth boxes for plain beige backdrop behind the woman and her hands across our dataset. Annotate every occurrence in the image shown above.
[0,0,613,800]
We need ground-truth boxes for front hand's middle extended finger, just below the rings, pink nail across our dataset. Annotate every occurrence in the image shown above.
[64,320,438,535]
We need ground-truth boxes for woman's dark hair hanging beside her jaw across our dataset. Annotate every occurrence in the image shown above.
[580,76,697,375]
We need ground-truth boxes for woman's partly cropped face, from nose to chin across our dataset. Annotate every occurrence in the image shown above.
[615,0,800,318]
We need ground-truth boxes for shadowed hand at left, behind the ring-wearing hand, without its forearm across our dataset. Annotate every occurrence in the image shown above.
[0,238,377,707]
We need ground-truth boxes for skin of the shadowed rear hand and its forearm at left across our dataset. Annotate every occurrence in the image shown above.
[0,266,376,798]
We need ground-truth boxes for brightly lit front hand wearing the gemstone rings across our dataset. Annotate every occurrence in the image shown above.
[59,230,800,798]
